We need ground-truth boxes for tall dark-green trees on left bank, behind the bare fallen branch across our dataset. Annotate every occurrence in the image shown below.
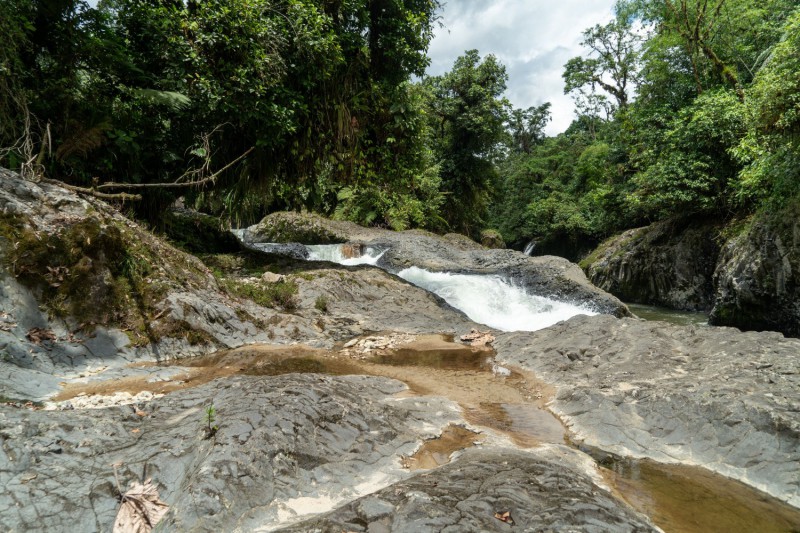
[0,0,438,225]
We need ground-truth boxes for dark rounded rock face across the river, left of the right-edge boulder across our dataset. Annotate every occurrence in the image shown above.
[581,219,720,311]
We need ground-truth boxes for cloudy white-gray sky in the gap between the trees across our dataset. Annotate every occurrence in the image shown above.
[428,0,614,135]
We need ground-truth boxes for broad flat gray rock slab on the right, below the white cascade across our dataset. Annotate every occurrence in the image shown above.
[494,316,800,507]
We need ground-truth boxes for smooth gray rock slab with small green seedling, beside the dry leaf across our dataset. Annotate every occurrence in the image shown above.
[0,374,466,532]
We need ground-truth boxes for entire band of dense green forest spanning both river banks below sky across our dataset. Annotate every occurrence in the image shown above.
[0,0,800,248]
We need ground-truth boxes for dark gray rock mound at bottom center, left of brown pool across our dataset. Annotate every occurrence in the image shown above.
[282,450,658,533]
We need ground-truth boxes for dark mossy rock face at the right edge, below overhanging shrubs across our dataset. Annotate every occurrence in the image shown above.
[710,205,800,337]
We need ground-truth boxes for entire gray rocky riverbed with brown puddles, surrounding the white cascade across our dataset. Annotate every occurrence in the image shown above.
[0,173,800,532]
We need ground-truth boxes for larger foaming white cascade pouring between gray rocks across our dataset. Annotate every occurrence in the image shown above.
[397,267,597,331]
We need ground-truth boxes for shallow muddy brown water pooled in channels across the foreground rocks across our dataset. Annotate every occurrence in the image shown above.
[56,335,800,533]
